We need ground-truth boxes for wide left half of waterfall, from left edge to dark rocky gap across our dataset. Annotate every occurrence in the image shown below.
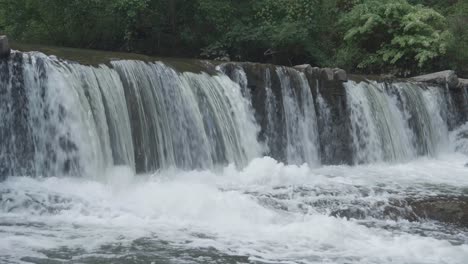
[0,52,262,177]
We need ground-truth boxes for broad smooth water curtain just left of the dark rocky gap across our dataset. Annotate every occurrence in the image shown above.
[112,61,261,171]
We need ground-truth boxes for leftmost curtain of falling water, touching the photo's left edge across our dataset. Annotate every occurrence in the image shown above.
[0,53,112,176]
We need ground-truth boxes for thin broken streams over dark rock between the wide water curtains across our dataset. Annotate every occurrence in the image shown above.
[219,65,320,165]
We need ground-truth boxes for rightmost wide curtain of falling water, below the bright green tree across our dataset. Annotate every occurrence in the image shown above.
[346,82,448,163]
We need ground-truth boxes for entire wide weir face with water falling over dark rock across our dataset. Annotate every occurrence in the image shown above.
[0,52,468,178]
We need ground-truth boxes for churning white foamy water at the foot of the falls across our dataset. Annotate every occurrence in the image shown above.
[0,154,468,263]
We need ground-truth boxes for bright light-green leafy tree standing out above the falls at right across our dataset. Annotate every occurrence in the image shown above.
[338,0,450,75]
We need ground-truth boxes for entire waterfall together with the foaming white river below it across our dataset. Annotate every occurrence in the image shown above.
[0,52,468,264]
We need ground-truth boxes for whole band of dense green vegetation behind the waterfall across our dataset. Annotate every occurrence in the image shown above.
[0,0,468,75]
